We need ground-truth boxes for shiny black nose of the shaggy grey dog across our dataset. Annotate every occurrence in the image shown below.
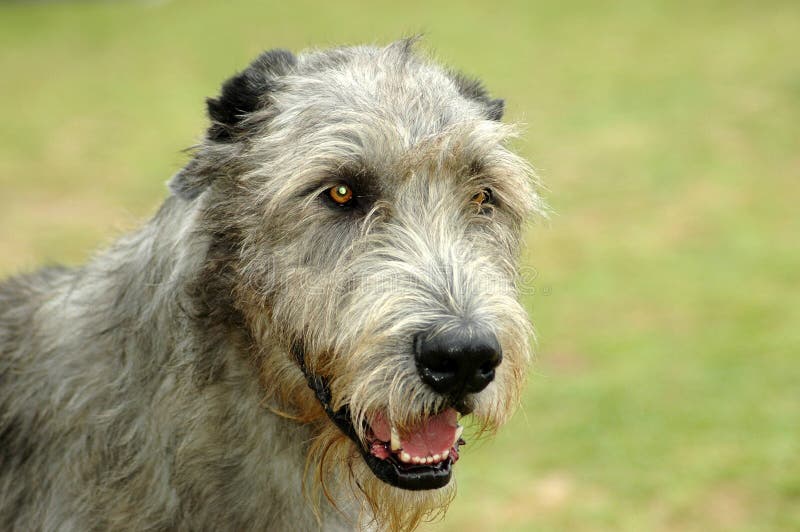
[414,328,503,400]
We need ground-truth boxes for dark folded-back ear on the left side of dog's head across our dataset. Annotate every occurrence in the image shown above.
[169,49,297,200]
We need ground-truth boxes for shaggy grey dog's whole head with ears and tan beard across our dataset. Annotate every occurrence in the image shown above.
[172,41,538,526]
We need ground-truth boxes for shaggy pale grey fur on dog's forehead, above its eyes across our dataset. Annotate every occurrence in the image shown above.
[247,41,514,185]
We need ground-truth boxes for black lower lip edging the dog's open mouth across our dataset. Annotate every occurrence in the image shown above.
[292,344,458,491]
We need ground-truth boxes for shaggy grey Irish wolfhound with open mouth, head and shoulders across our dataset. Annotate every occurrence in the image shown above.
[0,41,539,530]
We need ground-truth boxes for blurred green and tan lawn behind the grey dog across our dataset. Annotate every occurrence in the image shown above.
[0,0,800,531]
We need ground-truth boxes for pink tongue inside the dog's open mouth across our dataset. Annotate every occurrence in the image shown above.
[370,408,458,456]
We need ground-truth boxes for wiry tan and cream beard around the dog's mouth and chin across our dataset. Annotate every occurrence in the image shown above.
[245,254,530,530]
